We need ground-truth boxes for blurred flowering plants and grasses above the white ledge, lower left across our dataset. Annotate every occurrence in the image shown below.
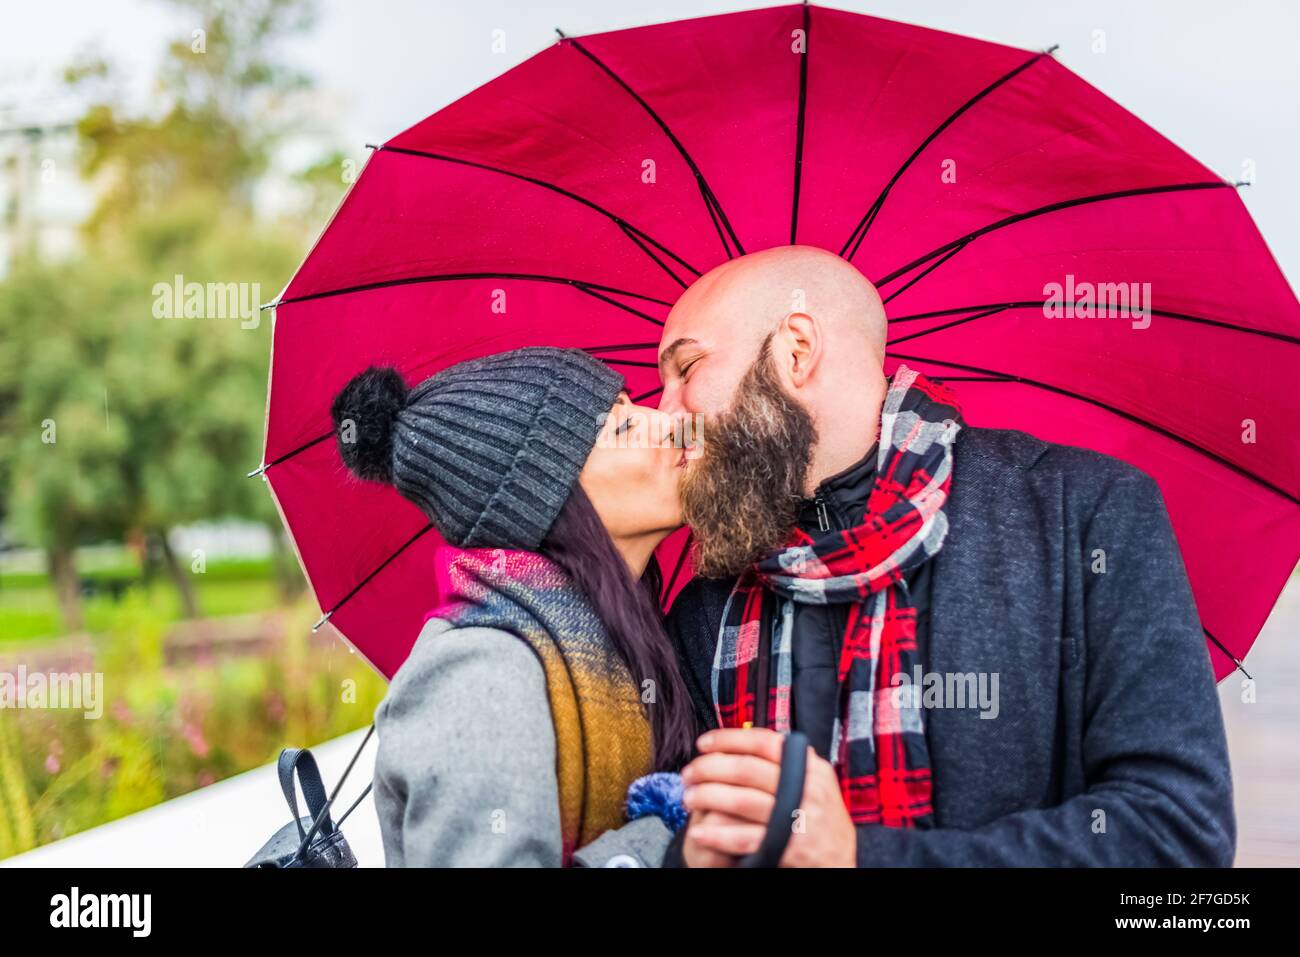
[0,597,385,865]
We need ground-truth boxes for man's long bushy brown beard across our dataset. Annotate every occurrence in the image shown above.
[681,335,816,579]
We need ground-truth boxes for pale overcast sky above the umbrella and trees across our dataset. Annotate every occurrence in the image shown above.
[0,0,1300,285]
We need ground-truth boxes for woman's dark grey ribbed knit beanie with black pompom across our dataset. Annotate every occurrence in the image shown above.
[332,346,624,549]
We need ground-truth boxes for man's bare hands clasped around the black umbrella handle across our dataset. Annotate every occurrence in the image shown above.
[681,728,858,867]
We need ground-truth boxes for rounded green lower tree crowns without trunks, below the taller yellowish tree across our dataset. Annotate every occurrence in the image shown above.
[0,214,299,546]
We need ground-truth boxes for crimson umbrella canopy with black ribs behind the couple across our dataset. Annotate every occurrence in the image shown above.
[259,5,1300,676]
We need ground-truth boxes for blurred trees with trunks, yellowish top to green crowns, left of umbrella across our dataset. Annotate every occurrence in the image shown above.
[0,0,343,628]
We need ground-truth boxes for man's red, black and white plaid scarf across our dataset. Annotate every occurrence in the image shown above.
[712,365,962,827]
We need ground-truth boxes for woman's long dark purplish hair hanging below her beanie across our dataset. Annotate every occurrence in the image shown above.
[538,484,696,770]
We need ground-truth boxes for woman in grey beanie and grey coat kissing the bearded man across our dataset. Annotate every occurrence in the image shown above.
[333,347,694,866]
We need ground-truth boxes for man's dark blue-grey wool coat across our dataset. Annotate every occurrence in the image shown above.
[670,428,1236,866]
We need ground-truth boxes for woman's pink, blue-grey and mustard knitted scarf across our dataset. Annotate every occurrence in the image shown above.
[425,546,653,866]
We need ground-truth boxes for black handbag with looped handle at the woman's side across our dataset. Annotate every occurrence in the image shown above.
[244,724,374,867]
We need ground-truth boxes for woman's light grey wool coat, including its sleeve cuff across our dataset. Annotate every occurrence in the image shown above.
[374,618,671,867]
